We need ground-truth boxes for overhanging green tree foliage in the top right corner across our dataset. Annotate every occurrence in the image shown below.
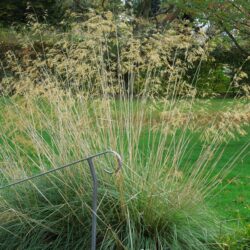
[160,0,250,56]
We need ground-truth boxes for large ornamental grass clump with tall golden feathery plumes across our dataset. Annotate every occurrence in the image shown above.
[0,12,249,249]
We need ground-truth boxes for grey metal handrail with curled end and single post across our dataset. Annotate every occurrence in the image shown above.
[0,150,122,250]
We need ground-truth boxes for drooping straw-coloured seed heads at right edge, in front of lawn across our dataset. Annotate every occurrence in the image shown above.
[154,100,250,142]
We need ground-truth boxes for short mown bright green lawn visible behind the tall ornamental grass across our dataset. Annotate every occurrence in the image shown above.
[0,99,250,229]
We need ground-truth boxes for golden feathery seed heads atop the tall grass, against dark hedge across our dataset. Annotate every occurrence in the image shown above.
[2,12,209,96]
